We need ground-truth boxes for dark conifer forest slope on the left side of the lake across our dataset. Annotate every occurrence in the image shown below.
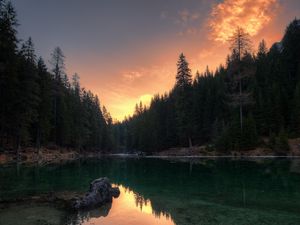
[0,0,113,151]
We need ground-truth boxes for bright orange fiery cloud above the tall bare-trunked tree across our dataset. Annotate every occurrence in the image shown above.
[208,0,279,42]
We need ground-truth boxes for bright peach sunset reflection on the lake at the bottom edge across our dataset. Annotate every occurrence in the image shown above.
[68,185,174,225]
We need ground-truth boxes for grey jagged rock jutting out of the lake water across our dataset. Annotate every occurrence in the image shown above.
[73,177,120,210]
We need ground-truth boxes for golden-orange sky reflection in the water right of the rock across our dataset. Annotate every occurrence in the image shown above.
[83,186,174,225]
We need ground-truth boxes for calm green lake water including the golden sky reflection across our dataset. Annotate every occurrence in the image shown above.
[0,158,300,225]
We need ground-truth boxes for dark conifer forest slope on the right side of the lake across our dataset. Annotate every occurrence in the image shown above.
[113,19,300,154]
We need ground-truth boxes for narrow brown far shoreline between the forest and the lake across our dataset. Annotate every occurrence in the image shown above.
[0,138,300,165]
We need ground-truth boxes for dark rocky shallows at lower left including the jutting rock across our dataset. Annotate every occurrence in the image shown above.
[0,177,120,225]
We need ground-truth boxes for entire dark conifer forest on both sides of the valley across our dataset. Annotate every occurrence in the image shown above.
[0,0,300,153]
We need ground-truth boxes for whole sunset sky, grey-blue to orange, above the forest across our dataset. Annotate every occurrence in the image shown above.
[12,0,300,120]
